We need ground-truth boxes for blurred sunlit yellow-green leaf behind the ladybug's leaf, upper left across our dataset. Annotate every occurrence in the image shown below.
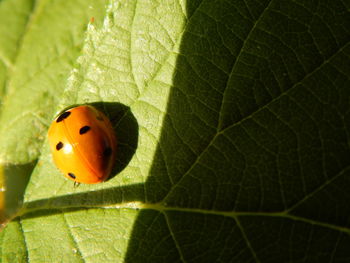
[0,0,105,164]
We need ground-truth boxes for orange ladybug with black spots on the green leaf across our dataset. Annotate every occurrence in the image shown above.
[48,105,116,185]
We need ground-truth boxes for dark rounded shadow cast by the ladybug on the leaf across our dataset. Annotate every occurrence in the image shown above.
[89,102,139,181]
